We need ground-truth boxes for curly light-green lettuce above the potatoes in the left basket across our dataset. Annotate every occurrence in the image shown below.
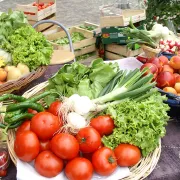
[2,25,53,71]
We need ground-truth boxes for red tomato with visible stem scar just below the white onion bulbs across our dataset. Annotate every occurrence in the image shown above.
[76,127,101,153]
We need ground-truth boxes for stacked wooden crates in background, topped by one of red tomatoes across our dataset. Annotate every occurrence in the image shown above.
[16,0,56,32]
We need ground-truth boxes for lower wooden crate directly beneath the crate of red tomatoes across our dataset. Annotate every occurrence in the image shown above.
[28,14,56,32]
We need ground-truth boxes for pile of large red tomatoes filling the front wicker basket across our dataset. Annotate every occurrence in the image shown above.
[14,101,141,180]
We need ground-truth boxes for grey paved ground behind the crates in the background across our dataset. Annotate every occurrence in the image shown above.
[0,0,137,26]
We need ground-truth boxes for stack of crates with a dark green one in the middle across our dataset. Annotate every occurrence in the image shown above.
[100,9,146,60]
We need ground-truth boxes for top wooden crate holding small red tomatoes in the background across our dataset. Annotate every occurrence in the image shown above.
[16,0,56,21]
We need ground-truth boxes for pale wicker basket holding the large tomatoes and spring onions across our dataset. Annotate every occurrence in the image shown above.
[1,81,161,180]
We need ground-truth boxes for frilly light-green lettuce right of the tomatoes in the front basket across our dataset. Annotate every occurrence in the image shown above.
[102,92,169,156]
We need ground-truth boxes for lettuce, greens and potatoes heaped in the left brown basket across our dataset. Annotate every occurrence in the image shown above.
[0,11,53,84]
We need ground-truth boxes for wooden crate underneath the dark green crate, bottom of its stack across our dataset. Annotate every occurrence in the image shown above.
[105,44,143,57]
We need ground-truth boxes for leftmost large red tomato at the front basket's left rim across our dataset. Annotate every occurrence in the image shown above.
[14,131,40,162]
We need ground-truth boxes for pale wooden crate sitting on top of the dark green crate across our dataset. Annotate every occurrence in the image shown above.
[100,9,146,28]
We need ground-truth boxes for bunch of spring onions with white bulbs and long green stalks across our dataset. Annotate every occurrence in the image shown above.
[59,68,155,133]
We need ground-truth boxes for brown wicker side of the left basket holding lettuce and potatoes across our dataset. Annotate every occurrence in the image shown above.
[0,66,47,95]
